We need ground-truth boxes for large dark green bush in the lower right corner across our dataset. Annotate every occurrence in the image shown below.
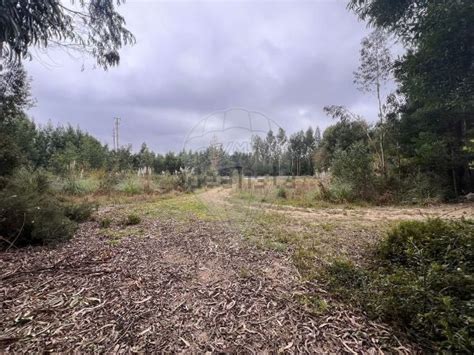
[326,219,474,353]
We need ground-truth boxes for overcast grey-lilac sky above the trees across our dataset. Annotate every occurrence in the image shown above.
[23,0,392,152]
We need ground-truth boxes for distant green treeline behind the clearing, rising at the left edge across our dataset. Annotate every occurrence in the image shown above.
[0,66,321,176]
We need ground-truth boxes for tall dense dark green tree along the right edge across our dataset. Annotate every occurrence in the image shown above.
[349,0,474,195]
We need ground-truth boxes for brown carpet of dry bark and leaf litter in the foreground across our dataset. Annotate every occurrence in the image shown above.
[0,197,412,353]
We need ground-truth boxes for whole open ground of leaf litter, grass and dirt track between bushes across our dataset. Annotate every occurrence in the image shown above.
[0,189,474,353]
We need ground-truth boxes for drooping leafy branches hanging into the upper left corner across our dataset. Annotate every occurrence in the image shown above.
[0,0,135,69]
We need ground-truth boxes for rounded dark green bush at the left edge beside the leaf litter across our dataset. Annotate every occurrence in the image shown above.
[0,169,77,248]
